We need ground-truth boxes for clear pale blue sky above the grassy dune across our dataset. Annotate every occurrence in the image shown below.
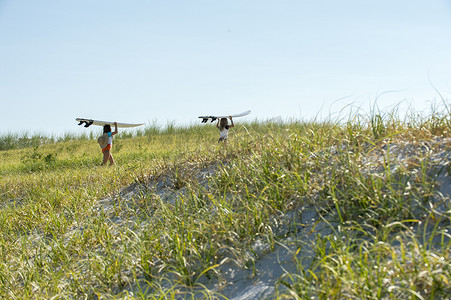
[0,0,451,134]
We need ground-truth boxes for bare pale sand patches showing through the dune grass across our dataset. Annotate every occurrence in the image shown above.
[67,139,451,299]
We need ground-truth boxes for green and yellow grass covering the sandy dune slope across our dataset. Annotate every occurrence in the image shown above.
[0,109,451,299]
